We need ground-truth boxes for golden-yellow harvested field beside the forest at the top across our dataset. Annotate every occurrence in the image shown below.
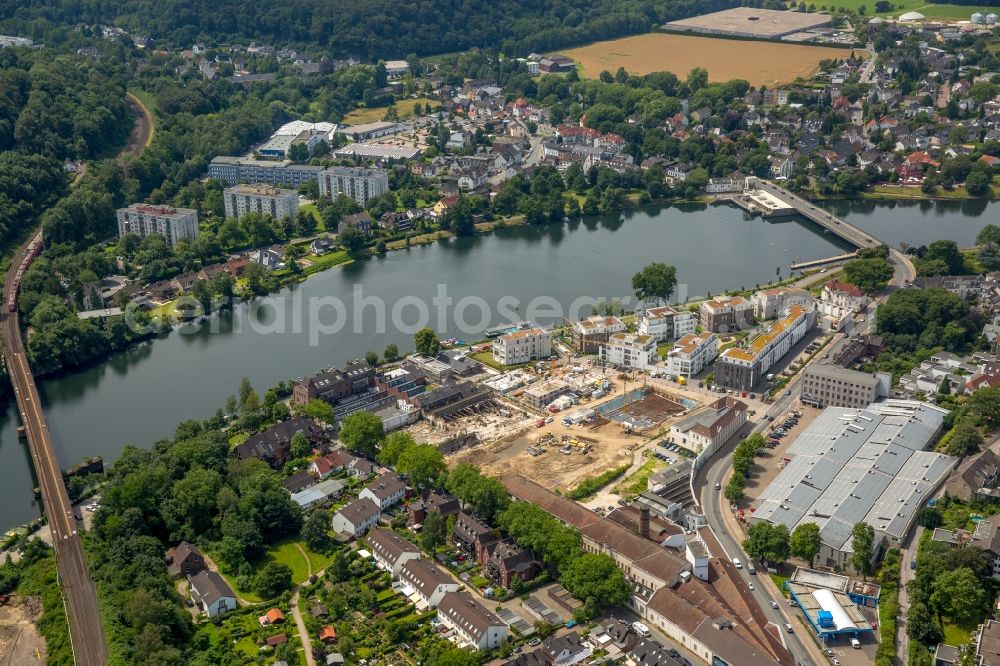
[562,33,857,86]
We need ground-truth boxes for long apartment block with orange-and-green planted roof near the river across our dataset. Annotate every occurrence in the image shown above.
[715,305,816,391]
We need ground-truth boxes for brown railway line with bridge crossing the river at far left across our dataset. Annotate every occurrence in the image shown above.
[2,232,107,666]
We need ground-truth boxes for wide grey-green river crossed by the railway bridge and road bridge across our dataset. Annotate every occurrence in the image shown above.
[0,201,1000,529]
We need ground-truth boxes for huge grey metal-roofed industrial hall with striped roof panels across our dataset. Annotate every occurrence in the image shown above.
[752,400,955,568]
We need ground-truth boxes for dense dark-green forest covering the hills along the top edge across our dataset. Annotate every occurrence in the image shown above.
[0,0,739,61]
